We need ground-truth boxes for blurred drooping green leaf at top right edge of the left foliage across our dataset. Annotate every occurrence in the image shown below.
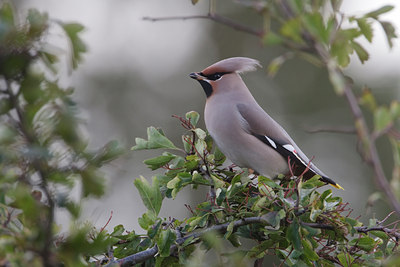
[60,23,86,69]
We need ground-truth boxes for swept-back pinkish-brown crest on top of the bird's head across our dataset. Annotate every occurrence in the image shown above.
[202,57,261,75]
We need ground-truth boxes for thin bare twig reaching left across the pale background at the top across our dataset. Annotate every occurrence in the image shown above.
[143,13,263,37]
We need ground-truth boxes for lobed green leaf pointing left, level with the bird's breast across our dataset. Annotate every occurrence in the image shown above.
[132,127,178,150]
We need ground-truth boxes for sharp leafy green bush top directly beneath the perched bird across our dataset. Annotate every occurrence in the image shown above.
[94,111,397,266]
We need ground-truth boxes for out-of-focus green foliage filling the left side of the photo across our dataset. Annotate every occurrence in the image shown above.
[0,1,122,266]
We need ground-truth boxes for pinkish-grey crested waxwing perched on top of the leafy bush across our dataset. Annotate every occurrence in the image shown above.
[189,57,343,189]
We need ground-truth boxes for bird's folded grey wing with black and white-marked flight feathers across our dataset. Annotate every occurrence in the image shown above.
[236,103,337,186]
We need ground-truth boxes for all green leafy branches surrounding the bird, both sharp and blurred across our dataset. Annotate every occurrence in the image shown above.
[0,0,400,266]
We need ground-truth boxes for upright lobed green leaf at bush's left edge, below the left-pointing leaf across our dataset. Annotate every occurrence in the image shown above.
[134,176,162,216]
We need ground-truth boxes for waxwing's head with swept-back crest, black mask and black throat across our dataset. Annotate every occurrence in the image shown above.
[189,57,261,97]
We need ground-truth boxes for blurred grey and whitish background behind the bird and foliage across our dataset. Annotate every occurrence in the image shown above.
[13,0,400,232]
